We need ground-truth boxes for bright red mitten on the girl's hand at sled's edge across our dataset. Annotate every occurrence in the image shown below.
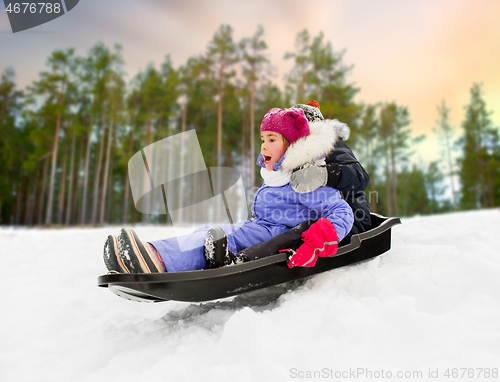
[287,218,339,268]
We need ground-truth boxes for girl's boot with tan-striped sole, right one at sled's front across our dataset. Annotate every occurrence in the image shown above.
[118,228,165,273]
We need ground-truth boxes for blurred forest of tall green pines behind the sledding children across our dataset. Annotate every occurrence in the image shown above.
[0,25,500,226]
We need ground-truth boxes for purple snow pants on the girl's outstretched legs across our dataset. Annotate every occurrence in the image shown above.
[149,219,289,272]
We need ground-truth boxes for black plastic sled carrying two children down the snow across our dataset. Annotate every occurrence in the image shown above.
[98,214,401,302]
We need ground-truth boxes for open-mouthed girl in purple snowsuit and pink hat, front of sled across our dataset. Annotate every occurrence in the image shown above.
[104,108,354,273]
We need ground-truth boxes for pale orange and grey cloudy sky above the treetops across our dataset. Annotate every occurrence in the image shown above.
[0,0,500,167]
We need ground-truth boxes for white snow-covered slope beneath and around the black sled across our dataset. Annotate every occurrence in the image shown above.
[0,209,500,382]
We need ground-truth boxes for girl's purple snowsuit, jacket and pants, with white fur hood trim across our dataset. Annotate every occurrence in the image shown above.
[151,113,354,272]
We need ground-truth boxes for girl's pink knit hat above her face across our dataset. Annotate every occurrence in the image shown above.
[260,108,309,144]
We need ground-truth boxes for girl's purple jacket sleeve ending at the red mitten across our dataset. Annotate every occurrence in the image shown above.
[299,187,354,241]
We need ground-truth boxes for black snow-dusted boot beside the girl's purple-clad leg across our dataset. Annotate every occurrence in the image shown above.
[204,227,249,268]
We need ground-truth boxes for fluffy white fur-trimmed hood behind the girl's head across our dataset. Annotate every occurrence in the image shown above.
[280,119,350,171]
